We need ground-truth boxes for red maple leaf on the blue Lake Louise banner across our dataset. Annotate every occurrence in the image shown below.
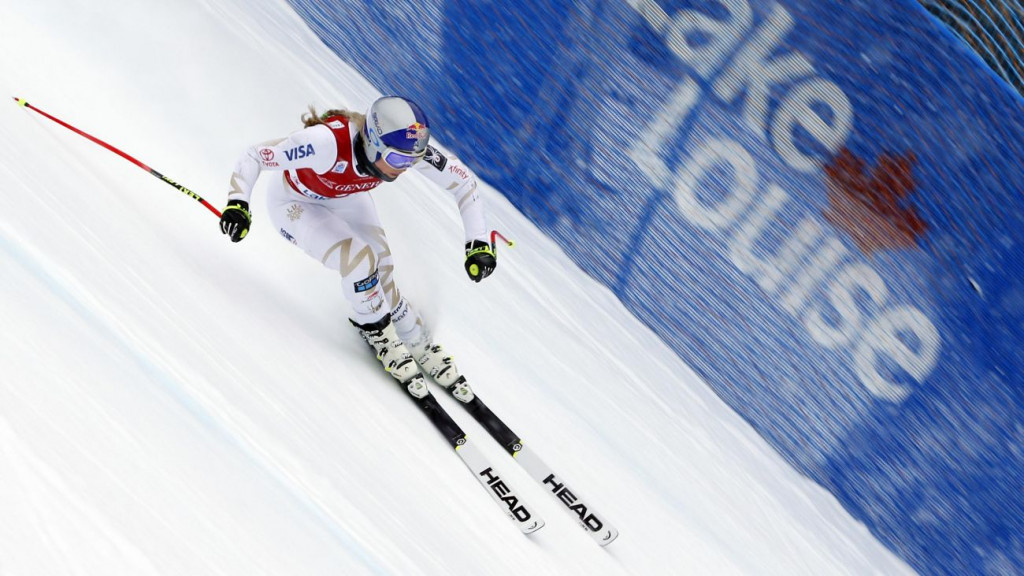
[823,148,928,255]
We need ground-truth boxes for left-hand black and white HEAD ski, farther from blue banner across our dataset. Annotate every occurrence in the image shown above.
[397,375,544,534]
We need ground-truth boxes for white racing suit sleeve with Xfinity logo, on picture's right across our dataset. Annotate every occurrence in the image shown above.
[413,146,490,243]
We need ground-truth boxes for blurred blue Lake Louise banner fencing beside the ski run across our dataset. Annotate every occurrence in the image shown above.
[292,0,1024,574]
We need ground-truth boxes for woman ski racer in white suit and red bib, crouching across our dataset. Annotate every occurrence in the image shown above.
[220,96,498,402]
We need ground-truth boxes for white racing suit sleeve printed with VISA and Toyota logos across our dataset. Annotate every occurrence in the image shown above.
[227,124,338,202]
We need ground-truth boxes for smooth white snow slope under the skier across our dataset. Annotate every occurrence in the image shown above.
[0,0,910,576]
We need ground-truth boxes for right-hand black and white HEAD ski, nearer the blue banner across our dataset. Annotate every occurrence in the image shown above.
[446,376,618,546]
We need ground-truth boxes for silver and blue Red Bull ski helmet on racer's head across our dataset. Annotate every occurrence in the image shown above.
[362,96,430,170]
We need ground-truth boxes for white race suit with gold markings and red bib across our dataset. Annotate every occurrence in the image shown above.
[227,116,487,344]
